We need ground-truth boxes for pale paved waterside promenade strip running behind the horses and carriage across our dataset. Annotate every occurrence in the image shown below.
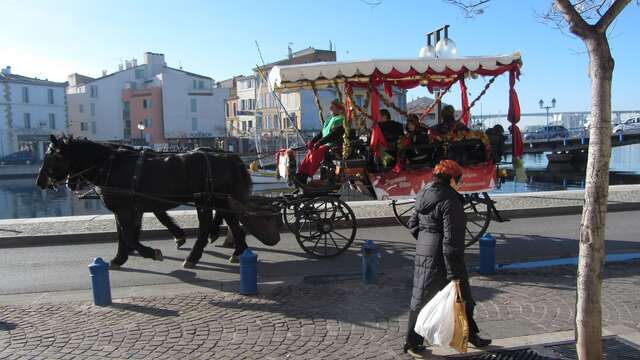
[0,185,640,247]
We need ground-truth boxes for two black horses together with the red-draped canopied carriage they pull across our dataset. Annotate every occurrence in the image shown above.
[37,53,521,268]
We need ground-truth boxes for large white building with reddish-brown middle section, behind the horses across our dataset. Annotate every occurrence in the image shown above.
[67,52,228,147]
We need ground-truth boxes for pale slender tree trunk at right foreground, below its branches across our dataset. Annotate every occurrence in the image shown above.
[575,32,614,360]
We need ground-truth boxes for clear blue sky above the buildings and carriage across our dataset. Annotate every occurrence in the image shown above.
[0,0,640,113]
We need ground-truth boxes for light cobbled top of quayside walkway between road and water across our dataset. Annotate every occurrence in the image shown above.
[0,185,640,240]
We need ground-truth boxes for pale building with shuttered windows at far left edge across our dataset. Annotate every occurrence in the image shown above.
[0,66,67,159]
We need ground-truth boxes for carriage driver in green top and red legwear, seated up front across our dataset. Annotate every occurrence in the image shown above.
[296,99,344,184]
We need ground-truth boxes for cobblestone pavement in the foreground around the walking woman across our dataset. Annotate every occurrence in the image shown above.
[0,262,640,359]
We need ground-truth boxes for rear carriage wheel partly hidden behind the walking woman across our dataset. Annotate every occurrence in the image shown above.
[391,194,491,247]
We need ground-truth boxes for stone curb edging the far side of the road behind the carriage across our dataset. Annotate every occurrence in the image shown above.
[0,202,640,249]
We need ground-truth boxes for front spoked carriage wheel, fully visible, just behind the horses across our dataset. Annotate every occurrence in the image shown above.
[294,196,357,257]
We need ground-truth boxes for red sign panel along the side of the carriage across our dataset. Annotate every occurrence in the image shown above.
[369,163,496,200]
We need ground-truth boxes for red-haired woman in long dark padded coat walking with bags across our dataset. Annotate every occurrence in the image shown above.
[404,160,491,357]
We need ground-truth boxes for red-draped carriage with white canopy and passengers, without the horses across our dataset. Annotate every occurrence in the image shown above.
[269,53,522,248]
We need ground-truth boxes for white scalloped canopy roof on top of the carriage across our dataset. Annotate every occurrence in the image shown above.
[269,52,520,89]
